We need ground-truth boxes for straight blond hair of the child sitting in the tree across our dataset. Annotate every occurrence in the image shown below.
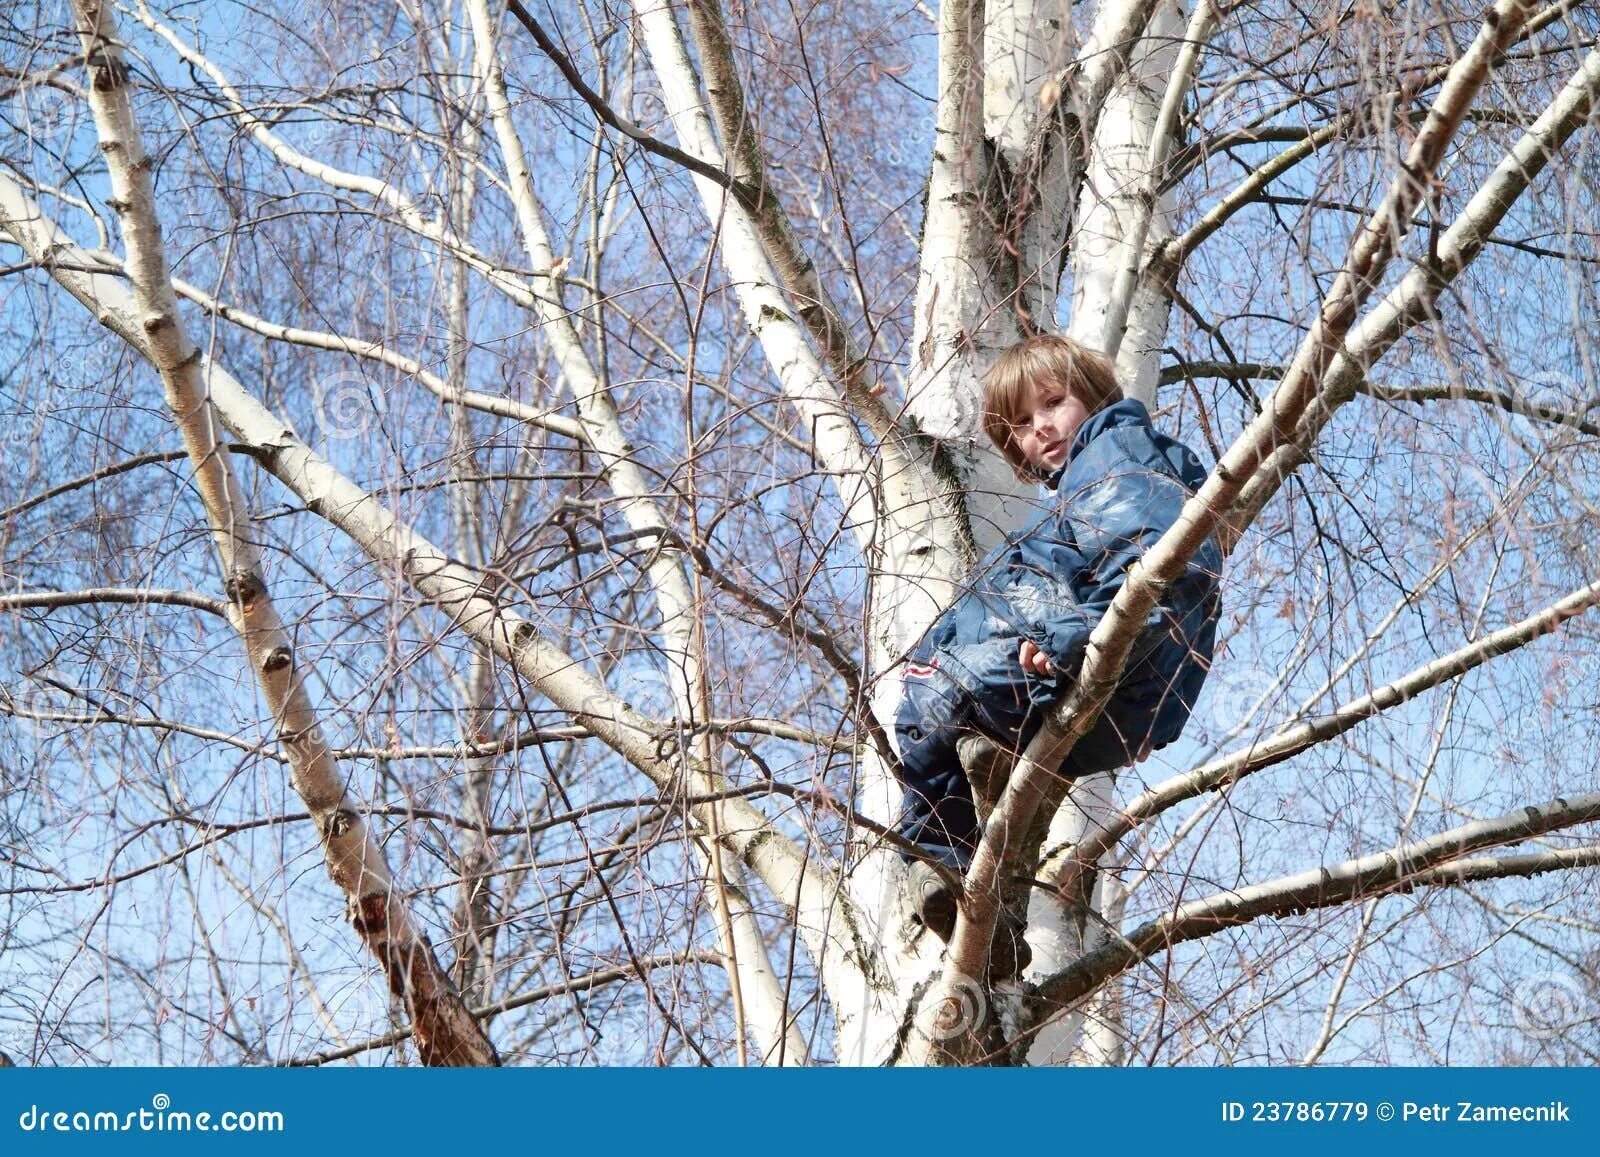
[984,333,1122,480]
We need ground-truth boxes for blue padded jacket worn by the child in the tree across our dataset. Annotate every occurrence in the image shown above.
[907,398,1222,771]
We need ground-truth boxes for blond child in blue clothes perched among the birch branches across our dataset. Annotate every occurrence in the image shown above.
[894,336,1222,965]
